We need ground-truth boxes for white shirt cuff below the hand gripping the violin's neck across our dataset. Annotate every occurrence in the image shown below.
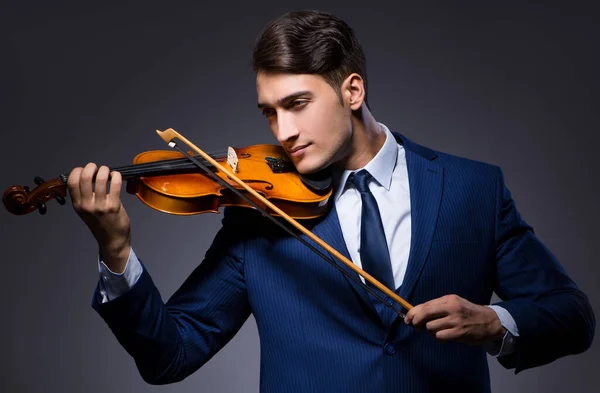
[98,247,143,303]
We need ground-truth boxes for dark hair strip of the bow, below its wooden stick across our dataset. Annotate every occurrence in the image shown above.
[166,141,405,318]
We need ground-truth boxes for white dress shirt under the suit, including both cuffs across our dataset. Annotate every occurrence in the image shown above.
[98,123,519,356]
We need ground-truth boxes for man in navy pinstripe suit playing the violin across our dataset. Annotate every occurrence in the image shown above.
[68,12,595,392]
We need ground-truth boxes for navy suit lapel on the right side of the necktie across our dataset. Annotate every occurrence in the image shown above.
[394,133,444,308]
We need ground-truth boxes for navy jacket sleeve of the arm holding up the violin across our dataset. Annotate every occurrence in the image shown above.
[92,209,250,384]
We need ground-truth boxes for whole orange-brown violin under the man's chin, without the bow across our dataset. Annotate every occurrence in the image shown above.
[2,140,332,219]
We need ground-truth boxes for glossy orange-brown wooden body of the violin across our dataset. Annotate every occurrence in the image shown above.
[126,144,332,219]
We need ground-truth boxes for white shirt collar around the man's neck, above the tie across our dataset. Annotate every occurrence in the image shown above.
[334,123,398,202]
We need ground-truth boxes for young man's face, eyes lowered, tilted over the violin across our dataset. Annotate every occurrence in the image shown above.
[256,72,352,174]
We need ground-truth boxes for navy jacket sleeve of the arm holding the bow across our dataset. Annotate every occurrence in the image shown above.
[494,168,596,373]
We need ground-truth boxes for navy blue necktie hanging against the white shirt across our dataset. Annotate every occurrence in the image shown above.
[348,169,396,291]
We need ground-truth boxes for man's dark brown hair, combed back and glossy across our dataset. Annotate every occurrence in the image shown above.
[252,11,367,103]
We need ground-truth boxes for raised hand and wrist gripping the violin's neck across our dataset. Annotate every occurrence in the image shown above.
[67,162,131,273]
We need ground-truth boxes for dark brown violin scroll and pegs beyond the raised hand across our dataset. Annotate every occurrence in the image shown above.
[2,175,67,215]
